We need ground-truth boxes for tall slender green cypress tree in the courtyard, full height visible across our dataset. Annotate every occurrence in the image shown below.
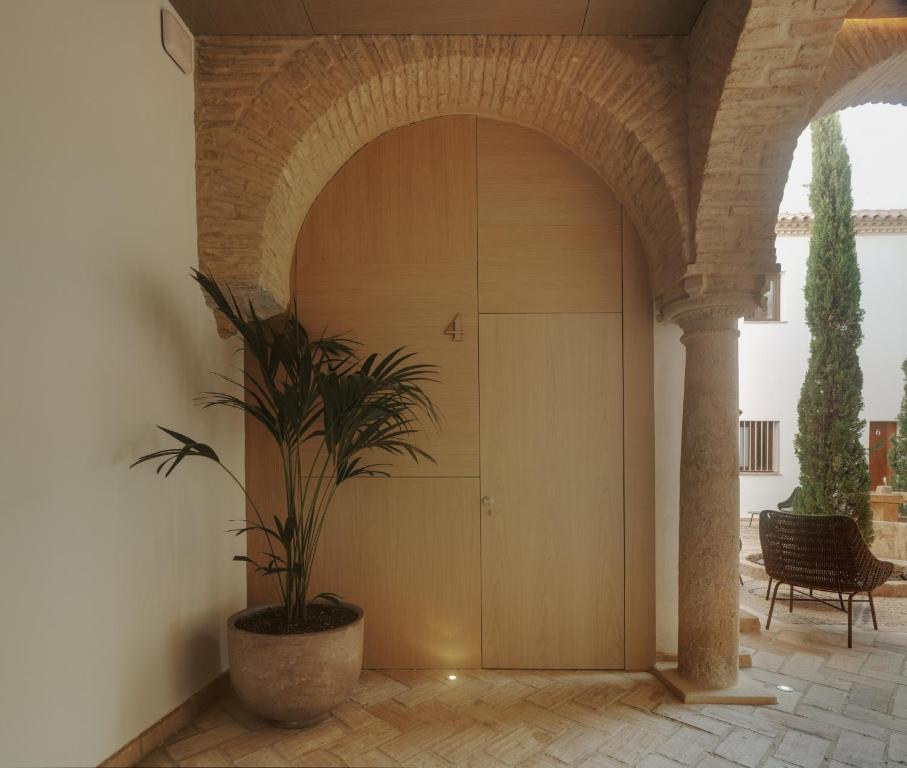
[794,115,872,541]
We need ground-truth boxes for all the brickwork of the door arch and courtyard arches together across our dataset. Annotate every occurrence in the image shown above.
[196,0,907,315]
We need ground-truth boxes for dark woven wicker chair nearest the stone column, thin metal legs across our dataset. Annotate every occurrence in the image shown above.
[759,510,894,648]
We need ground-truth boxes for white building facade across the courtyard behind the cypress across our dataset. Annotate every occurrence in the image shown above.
[740,210,907,516]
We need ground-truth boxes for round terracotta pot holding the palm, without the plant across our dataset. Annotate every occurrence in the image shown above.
[227,603,365,728]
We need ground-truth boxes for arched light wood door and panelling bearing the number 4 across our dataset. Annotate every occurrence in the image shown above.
[247,116,654,668]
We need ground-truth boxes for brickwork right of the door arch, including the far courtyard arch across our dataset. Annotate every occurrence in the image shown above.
[688,7,907,308]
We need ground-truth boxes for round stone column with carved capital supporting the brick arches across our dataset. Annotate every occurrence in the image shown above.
[665,297,752,690]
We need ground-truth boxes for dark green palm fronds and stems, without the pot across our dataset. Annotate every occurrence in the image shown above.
[132,270,441,622]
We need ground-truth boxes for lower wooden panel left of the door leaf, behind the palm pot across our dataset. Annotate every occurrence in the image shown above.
[312,478,481,669]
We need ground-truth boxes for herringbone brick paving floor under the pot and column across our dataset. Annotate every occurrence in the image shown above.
[140,604,907,768]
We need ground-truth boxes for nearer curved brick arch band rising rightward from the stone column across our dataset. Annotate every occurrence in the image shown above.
[675,0,852,308]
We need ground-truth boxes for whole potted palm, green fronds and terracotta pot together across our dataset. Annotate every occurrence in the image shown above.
[133,270,438,727]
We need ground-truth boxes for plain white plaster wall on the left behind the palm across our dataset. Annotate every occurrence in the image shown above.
[0,0,245,765]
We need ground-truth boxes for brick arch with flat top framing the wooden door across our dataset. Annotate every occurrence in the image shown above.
[196,36,690,314]
